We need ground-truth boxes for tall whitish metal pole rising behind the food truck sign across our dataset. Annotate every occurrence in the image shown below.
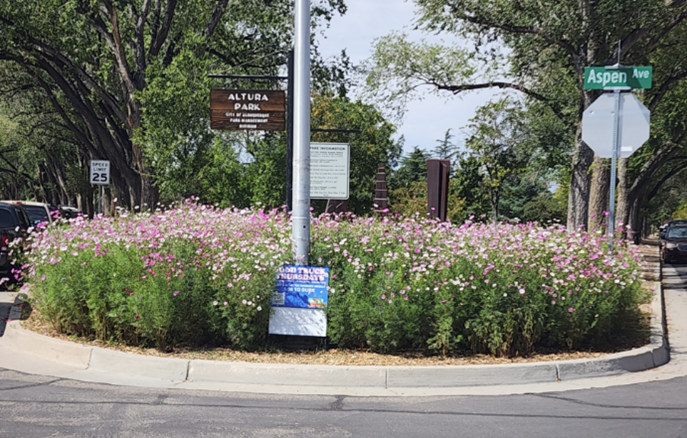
[291,0,310,265]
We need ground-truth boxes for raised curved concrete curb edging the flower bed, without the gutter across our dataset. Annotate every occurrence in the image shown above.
[0,246,669,389]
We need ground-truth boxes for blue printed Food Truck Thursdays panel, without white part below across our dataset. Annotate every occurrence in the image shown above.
[270,265,329,309]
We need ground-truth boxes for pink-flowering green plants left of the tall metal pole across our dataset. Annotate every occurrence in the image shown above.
[26,201,290,349]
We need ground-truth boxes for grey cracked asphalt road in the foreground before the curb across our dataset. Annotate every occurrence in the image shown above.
[0,265,687,438]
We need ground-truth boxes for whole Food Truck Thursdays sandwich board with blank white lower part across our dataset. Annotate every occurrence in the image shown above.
[269,265,329,338]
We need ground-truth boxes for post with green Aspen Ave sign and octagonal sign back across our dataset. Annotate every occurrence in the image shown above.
[582,63,653,251]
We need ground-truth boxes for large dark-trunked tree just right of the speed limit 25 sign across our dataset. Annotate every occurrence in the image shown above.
[0,0,345,206]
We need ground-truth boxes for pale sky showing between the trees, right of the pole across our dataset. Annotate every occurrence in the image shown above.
[318,0,496,157]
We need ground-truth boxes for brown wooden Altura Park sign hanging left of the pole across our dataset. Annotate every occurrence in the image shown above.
[210,90,286,131]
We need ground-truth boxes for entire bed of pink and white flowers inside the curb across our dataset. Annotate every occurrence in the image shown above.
[28,201,645,355]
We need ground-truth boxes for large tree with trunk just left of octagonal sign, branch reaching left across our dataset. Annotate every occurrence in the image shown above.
[370,0,687,228]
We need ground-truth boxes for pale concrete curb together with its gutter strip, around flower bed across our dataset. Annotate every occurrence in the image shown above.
[0,246,687,396]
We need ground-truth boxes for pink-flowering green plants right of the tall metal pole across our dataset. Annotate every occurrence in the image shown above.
[311,218,646,356]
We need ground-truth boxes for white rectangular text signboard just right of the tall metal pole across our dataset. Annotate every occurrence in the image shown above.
[310,143,351,199]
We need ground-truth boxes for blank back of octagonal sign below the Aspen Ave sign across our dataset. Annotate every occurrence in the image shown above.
[582,93,651,158]
